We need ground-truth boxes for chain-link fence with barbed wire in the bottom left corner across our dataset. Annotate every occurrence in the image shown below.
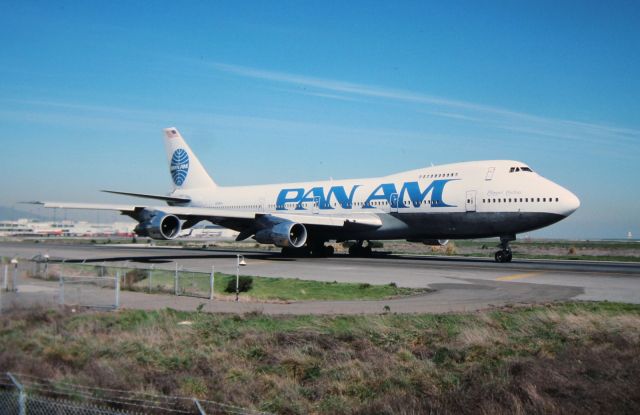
[0,373,266,415]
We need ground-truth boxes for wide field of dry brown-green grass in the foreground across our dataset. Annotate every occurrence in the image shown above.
[0,302,640,414]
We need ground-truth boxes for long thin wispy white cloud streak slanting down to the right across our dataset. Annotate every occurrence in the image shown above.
[209,63,640,145]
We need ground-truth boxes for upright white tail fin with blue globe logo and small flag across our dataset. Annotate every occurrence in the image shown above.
[164,127,217,189]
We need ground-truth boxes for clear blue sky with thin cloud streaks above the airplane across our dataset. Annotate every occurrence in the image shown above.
[0,1,640,238]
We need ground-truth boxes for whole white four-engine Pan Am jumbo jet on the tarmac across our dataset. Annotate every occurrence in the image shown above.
[33,127,580,263]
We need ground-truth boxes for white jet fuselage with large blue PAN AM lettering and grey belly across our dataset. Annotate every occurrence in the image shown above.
[172,160,580,239]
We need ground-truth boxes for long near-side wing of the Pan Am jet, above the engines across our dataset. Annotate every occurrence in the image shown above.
[31,202,382,230]
